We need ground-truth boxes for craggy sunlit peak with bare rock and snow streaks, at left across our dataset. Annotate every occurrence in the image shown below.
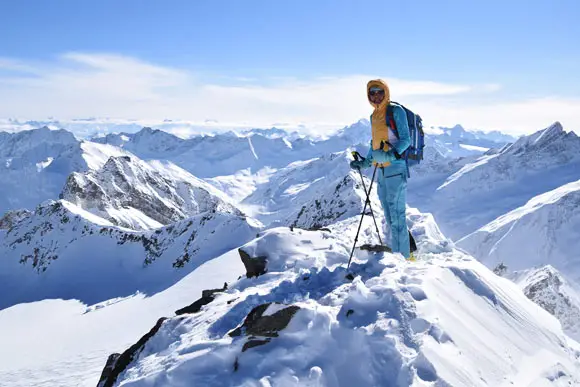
[60,152,241,230]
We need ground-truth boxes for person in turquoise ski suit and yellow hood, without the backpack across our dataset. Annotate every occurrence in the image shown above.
[350,79,415,260]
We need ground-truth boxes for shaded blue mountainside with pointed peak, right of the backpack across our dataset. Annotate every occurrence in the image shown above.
[409,123,580,240]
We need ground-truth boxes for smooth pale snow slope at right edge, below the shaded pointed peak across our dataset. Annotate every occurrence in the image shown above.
[457,180,580,281]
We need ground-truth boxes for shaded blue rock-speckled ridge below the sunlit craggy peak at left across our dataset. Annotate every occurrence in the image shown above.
[0,201,261,309]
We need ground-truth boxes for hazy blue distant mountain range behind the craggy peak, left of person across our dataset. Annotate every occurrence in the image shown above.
[0,120,516,218]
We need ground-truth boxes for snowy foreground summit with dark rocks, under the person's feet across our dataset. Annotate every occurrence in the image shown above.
[99,223,580,387]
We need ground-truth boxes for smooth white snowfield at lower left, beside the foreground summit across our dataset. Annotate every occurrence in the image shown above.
[0,251,243,387]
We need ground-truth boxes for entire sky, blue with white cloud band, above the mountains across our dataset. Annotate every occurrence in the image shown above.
[0,0,580,132]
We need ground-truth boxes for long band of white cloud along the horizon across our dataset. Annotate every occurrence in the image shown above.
[0,53,580,134]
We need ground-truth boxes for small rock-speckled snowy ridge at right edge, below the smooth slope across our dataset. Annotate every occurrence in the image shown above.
[507,265,580,341]
